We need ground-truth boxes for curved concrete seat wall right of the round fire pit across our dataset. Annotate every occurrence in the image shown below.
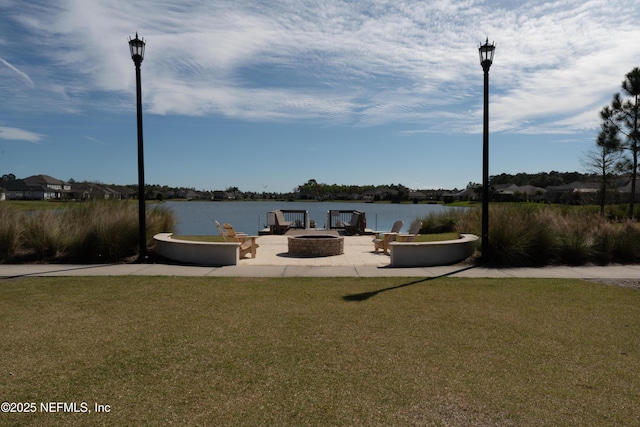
[389,234,479,267]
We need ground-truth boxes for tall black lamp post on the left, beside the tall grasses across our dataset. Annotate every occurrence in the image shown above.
[129,33,147,263]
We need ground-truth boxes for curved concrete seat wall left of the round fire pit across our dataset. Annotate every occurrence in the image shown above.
[153,233,240,266]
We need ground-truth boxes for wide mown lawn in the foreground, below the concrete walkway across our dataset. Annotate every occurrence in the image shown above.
[0,277,640,426]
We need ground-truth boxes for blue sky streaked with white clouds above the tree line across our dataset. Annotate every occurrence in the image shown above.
[0,0,640,192]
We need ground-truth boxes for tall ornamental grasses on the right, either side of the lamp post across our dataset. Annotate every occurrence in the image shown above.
[421,204,640,267]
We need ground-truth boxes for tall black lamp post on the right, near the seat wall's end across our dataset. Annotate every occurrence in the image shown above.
[479,37,496,262]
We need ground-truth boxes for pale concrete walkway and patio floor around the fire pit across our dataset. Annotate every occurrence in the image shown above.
[0,236,640,280]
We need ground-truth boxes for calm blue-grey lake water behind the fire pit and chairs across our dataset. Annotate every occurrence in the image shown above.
[161,201,464,235]
